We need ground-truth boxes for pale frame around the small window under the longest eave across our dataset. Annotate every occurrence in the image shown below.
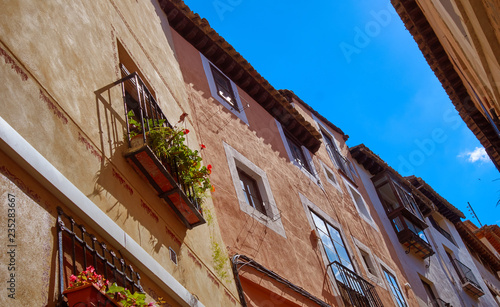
[200,53,248,125]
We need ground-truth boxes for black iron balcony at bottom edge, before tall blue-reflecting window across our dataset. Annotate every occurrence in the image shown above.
[329,261,383,307]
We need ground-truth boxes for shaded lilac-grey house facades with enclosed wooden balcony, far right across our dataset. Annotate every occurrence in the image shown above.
[351,145,500,306]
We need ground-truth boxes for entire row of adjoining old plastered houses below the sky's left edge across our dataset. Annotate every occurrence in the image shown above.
[0,0,500,307]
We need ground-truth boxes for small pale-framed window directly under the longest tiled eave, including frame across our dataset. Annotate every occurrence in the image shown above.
[200,53,248,125]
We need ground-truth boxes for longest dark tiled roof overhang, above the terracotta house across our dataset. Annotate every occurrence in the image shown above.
[159,0,321,152]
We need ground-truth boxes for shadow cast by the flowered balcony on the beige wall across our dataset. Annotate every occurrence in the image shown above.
[87,85,187,252]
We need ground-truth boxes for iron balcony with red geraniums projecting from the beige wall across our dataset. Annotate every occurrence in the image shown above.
[101,71,206,229]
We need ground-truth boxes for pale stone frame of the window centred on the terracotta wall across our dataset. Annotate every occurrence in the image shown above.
[223,142,286,238]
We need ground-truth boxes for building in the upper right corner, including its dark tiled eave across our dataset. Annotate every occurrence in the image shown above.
[391,0,500,170]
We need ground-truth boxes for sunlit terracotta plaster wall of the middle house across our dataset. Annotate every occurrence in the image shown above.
[172,25,414,305]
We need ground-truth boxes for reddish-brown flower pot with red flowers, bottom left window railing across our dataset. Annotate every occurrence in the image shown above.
[63,284,121,307]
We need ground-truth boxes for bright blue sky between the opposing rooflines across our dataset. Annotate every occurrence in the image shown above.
[185,0,500,225]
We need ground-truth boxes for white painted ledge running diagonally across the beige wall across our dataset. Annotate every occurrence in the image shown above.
[0,117,204,307]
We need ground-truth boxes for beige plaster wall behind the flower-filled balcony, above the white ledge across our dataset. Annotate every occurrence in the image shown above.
[0,0,237,306]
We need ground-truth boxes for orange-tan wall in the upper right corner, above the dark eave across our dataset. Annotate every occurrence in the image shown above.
[417,0,500,122]
